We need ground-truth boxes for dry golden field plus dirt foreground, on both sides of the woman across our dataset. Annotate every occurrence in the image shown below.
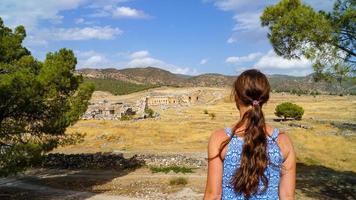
[0,88,356,200]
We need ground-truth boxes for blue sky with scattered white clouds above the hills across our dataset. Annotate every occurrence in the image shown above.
[0,0,334,76]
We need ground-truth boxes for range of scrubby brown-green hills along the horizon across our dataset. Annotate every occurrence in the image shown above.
[77,67,356,94]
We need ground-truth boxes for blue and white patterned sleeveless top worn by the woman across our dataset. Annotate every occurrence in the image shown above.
[221,128,284,200]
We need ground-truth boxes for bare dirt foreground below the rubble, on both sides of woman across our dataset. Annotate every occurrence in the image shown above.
[0,155,356,200]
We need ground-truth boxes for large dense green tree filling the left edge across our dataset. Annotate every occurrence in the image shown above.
[0,18,94,175]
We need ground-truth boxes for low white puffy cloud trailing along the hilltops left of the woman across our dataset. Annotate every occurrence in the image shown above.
[125,50,197,74]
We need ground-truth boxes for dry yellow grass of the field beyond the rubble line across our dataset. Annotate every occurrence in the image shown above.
[55,88,356,171]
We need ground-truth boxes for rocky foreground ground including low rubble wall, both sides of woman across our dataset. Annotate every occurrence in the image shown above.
[0,154,356,200]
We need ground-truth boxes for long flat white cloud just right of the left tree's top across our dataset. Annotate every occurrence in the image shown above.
[52,26,122,40]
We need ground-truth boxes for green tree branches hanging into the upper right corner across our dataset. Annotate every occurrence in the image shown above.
[261,0,356,84]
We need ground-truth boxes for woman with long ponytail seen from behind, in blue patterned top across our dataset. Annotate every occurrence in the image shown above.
[204,69,296,200]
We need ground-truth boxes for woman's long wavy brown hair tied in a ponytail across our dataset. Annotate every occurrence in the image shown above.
[224,69,270,198]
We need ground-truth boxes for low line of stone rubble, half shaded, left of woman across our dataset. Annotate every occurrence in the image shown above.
[41,153,207,169]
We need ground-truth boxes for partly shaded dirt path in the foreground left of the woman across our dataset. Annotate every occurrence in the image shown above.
[0,170,204,200]
